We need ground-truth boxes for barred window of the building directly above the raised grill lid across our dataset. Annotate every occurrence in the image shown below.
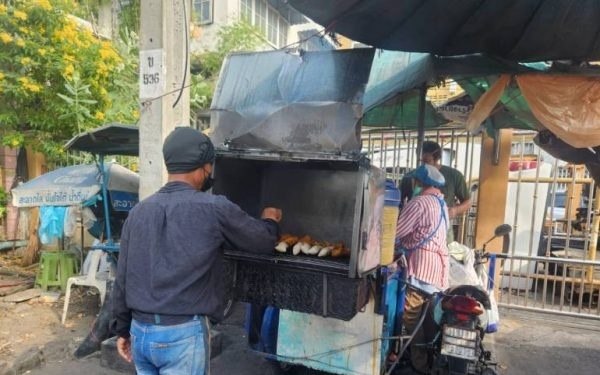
[240,0,289,47]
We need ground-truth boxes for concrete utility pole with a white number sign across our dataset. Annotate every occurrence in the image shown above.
[139,0,192,199]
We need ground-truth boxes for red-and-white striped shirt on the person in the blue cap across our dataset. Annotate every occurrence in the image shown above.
[396,188,449,290]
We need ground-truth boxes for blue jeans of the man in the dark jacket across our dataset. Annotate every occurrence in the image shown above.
[130,316,210,375]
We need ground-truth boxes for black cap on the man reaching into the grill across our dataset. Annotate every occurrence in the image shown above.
[163,127,215,174]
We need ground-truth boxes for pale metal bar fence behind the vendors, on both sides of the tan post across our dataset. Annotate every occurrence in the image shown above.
[362,128,600,319]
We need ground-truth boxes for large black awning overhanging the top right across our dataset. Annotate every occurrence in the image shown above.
[288,0,600,61]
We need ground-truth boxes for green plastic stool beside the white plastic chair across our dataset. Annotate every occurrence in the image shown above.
[35,251,77,291]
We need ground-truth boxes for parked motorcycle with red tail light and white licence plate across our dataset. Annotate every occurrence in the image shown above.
[387,224,512,375]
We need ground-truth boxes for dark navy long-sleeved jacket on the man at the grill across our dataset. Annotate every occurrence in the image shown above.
[113,182,279,337]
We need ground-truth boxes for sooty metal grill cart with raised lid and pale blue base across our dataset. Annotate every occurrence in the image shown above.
[211,49,404,374]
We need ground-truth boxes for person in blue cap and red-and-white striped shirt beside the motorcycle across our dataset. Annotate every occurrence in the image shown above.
[396,165,449,372]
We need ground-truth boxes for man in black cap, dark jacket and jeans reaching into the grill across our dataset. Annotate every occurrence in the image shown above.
[113,127,281,375]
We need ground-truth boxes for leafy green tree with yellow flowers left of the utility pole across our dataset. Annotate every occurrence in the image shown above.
[0,0,137,157]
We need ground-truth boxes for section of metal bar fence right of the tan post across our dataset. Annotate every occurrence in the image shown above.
[499,132,600,319]
